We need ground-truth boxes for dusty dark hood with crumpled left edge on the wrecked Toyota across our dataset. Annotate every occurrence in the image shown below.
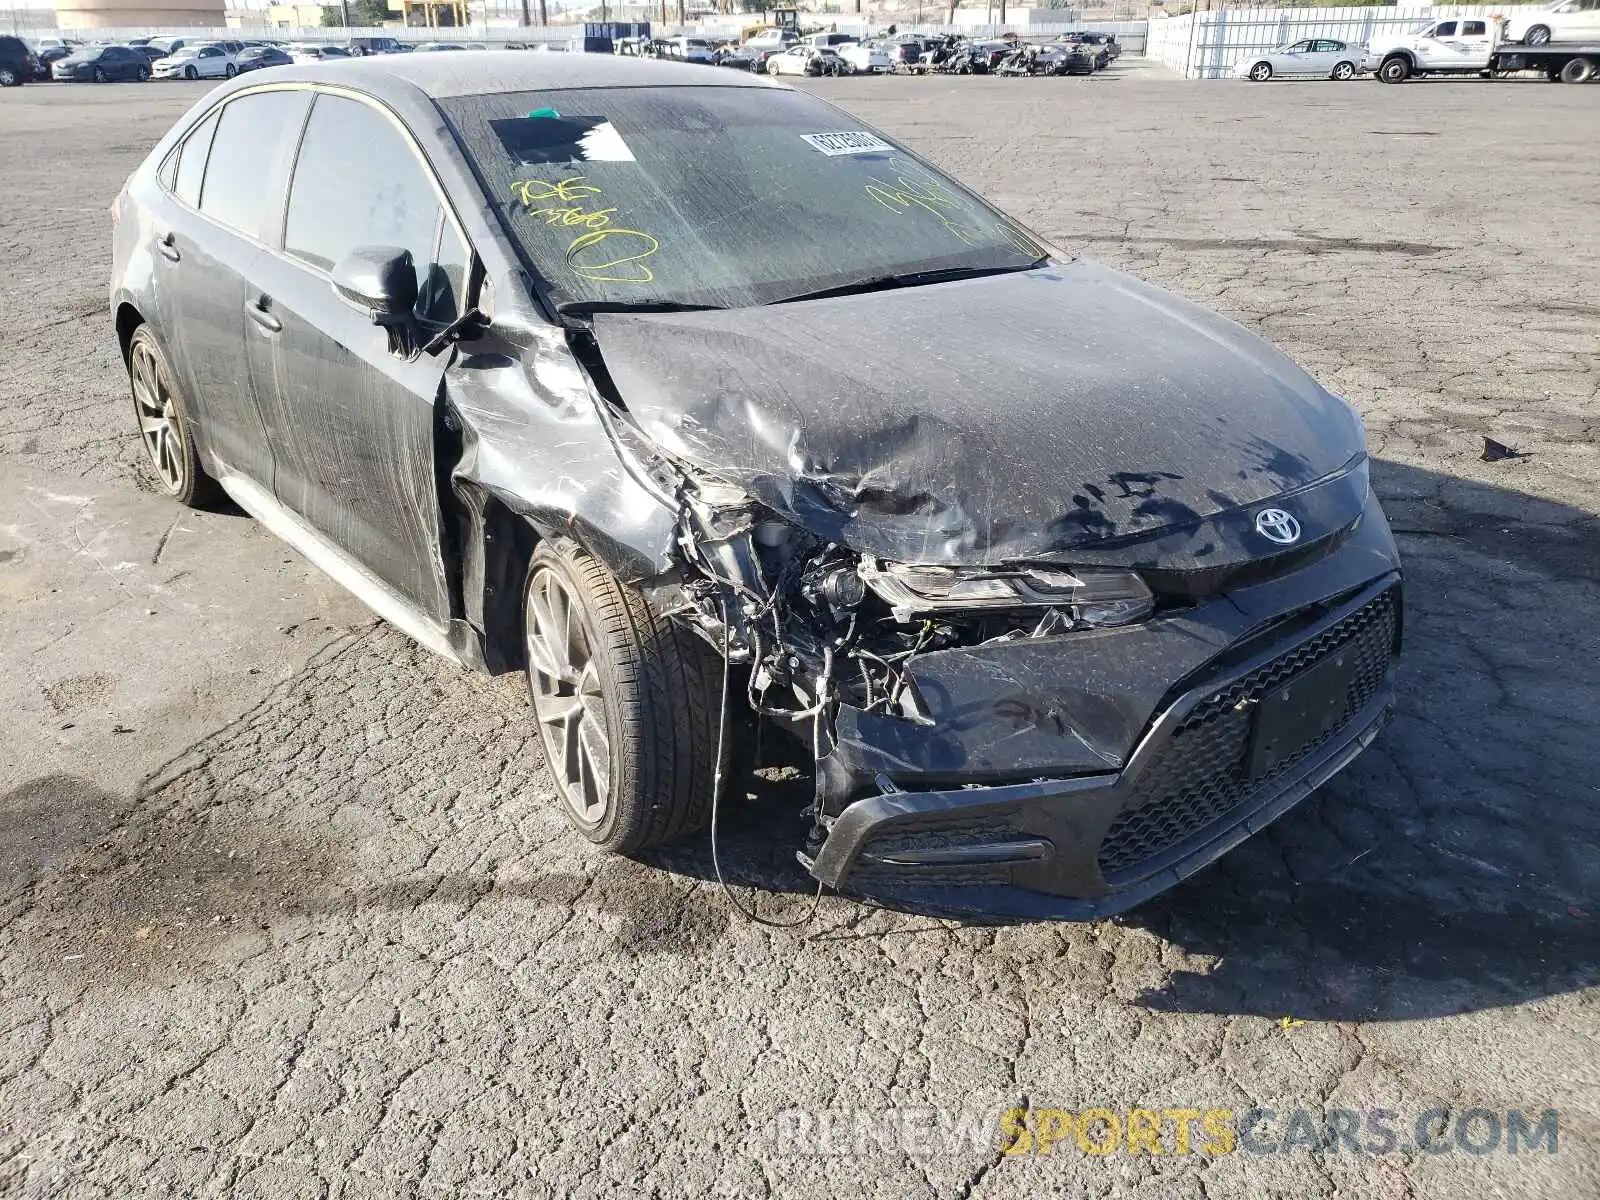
[594,262,1362,565]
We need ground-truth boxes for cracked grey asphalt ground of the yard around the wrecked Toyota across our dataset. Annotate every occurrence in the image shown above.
[0,62,1600,1200]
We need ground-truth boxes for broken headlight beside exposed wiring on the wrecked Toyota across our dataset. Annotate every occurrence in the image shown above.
[859,558,1154,626]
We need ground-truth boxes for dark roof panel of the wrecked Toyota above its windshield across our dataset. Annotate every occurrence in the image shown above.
[259,50,773,99]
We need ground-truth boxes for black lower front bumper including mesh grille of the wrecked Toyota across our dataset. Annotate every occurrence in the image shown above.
[805,576,1400,920]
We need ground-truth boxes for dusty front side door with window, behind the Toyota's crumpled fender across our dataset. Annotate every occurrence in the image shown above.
[241,93,470,621]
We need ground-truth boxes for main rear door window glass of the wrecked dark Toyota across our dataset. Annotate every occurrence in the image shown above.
[196,91,309,238]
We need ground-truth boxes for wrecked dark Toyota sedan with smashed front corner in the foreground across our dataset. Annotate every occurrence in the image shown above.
[110,51,1402,917]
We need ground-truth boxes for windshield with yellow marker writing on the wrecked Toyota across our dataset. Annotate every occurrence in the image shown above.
[438,88,1045,307]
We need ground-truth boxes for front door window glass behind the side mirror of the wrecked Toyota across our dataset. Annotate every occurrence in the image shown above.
[283,94,440,302]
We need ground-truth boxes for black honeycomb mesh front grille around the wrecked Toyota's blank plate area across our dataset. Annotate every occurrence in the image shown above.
[1099,589,1400,883]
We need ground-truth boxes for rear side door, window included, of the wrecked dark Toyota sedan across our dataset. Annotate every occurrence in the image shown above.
[154,91,310,485]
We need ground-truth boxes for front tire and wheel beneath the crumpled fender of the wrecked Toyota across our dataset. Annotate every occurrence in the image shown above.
[523,539,723,854]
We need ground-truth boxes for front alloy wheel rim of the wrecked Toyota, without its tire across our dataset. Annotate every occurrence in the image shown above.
[526,566,611,829]
